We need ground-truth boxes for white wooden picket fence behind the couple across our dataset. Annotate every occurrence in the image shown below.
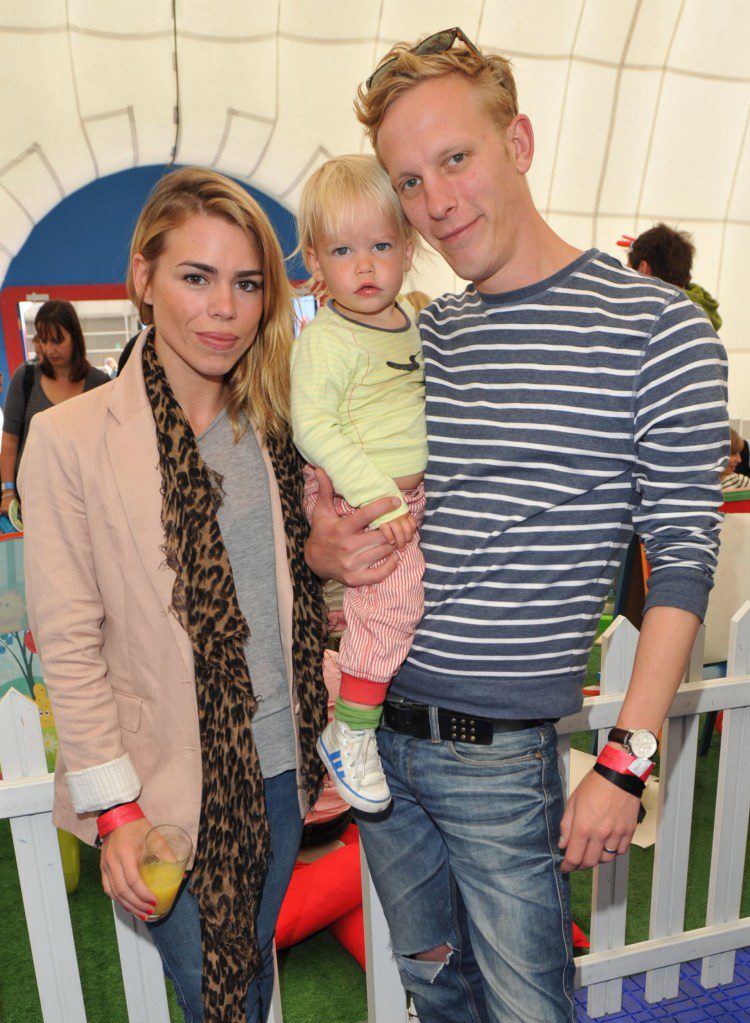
[0,603,750,1023]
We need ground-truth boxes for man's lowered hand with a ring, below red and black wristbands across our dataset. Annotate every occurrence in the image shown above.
[560,771,641,874]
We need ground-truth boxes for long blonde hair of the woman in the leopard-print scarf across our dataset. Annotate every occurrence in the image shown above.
[127,167,293,441]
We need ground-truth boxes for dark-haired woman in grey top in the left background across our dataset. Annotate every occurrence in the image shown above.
[0,299,109,515]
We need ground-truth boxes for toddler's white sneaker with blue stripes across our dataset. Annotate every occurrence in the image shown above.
[315,718,392,818]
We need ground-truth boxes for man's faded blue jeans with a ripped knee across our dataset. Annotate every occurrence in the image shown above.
[359,724,576,1023]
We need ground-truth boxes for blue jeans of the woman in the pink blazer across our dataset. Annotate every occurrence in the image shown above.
[148,770,302,1023]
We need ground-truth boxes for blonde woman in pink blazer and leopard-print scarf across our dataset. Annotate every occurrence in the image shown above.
[20,169,326,1023]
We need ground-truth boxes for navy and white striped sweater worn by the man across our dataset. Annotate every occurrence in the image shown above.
[391,250,729,718]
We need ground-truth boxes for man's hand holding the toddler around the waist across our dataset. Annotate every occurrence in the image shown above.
[305,469,398,586]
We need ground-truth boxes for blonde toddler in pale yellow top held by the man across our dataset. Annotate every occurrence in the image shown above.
[292,155,427,819]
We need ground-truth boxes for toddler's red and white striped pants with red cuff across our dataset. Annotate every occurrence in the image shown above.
[304,465,425,706]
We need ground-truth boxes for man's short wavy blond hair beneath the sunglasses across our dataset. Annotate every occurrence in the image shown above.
[354,43,519,151]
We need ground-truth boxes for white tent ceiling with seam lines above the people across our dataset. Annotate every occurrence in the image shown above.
[0,0,750,414]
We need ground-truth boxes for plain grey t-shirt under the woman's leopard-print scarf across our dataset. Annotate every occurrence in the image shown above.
[197,410,296,779]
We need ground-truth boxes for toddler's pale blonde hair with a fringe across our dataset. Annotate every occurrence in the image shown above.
[297,154,418,273]
